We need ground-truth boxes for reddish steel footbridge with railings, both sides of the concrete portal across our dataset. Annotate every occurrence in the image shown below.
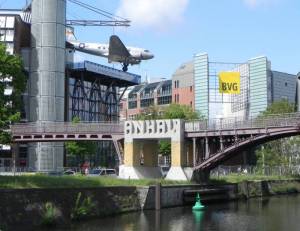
[11,113,300,170]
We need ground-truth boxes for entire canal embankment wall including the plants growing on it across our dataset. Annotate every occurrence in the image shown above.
[0,177,300,230]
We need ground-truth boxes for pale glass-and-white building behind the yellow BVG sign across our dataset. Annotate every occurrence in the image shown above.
[194,53,297,119]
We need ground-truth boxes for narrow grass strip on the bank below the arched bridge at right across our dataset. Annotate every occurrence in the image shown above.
[210,174,300,183]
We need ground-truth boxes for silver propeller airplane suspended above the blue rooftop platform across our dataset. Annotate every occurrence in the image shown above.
[66,28,154,72]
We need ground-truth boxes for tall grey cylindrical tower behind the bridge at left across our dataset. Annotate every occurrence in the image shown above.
[28,0,66,171]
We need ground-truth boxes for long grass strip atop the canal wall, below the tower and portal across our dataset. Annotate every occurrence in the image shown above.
[0,174,191,189]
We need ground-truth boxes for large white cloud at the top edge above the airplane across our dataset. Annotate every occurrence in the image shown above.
[116,0,189,30]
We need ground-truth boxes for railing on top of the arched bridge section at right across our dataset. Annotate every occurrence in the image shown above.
[185,113,300,132]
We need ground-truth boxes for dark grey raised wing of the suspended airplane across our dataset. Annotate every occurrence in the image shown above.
[108,35,130,63]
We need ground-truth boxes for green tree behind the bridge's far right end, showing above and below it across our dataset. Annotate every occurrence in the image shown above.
[256,99,300,166]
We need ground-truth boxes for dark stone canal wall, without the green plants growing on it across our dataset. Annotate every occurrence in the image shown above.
[0,181,300,230]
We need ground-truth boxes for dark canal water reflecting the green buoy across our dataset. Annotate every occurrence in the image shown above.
[58,195,300,231]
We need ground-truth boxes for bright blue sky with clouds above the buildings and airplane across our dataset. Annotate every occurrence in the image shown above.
[0,0,300,79]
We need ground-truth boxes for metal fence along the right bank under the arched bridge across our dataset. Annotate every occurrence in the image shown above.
[210,165,300,177]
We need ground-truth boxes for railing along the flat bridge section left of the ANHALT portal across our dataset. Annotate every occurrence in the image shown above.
[11,122,124,135]
